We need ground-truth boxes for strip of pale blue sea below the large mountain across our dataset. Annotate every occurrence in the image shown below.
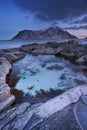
[0,39,68,49]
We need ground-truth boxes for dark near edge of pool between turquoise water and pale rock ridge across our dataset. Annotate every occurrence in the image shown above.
[11,88,64,104]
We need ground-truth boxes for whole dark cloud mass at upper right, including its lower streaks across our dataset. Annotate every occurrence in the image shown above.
[13,0,87,30]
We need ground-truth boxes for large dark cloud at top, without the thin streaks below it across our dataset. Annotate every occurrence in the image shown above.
[13,0,87,20]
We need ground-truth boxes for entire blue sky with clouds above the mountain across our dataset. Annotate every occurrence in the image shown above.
[0,0,87,40]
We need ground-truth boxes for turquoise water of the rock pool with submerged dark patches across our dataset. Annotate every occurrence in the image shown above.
[11,55,87,96]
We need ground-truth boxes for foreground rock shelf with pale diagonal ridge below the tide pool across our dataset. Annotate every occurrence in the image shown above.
[0,86,87,130]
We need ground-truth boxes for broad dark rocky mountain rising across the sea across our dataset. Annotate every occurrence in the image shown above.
[12,26,77,40]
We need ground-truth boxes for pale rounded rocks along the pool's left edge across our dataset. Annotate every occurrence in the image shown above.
[0,58,15,111]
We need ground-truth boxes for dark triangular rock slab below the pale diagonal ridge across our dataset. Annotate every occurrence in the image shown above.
[31,105,81,130]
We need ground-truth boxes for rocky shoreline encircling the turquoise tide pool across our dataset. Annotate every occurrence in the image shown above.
[0,40,87,130]
